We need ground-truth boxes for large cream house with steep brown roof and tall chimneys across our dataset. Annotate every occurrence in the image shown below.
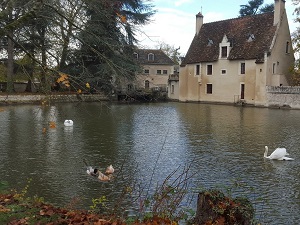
[179,0,294,105]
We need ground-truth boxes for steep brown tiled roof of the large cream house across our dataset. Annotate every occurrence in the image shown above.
[181,13,276,66]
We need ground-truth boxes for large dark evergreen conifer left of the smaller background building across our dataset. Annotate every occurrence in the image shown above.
[67,0,154,93]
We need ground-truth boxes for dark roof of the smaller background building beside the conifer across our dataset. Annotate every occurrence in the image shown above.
[134,49,174,65]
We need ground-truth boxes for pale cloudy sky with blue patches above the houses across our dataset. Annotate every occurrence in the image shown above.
[138,0,298,55]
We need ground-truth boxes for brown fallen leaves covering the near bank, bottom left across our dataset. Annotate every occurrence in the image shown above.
[0,194,177,225]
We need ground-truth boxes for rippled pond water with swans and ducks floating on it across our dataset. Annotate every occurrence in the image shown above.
[0,103,300,224]
